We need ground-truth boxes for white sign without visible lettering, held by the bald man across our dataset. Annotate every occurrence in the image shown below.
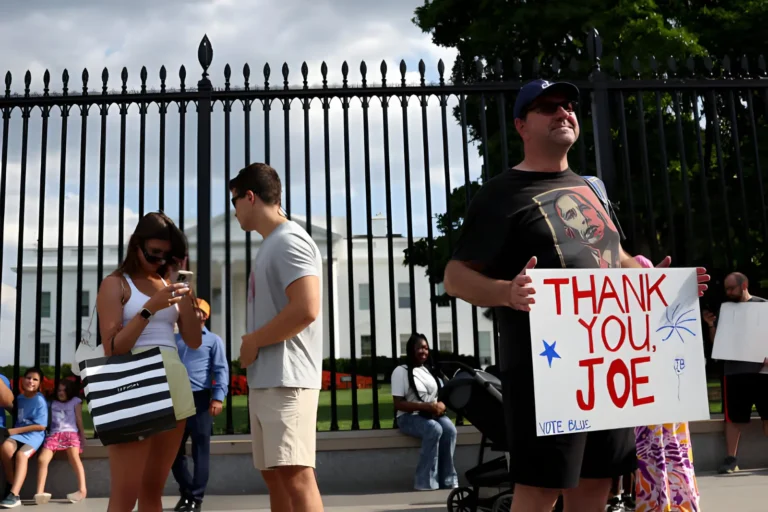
[712,302,768,363]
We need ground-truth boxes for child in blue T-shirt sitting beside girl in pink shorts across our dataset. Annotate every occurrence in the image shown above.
[0,368,48,508]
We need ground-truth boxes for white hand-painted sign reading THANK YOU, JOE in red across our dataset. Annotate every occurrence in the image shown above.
[528,269,709,436]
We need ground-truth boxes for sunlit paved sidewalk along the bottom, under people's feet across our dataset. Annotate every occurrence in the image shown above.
[22,470,768,512]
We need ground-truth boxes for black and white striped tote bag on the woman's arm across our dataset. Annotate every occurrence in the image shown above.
[80,348,176,445]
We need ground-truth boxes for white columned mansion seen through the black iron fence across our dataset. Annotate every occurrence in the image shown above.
[9,215,493,372]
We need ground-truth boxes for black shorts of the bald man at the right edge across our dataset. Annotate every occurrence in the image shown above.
[723,373,768,423]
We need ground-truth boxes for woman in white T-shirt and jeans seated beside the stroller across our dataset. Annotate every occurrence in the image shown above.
[392,334,459,491]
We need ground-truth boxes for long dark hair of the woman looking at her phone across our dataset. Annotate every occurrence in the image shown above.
[117,212,187,276]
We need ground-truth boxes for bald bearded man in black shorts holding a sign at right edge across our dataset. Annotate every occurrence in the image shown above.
[704,272,768,474]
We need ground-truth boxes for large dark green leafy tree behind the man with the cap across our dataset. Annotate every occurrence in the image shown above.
[405,0,768,301]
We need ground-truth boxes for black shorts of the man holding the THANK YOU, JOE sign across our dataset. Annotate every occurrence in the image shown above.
[502,367,637,489]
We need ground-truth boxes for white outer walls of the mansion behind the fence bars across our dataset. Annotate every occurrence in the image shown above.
[9,216,493,365]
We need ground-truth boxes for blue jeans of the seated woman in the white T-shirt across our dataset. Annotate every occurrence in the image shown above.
[397,414,458,490]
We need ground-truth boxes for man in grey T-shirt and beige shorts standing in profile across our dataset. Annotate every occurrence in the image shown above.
[229,163,323,512]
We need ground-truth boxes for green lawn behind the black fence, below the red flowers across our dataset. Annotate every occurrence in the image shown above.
[24,381,722,437]
